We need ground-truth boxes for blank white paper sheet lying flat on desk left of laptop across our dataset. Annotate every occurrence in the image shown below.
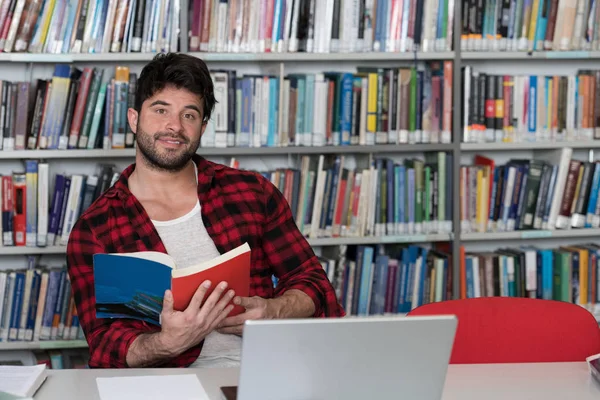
[96,374,209,400]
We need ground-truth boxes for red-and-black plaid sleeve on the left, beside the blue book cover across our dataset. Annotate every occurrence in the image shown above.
[67,219,156,368]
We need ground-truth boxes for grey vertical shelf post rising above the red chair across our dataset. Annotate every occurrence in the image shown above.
[446,0,462,299]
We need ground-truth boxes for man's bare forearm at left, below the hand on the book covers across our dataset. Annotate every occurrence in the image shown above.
[127,332,177,368]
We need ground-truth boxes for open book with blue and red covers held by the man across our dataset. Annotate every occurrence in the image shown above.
[94,243,250,325]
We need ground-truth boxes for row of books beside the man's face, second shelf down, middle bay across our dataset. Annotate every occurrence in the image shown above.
[201,61,453,147]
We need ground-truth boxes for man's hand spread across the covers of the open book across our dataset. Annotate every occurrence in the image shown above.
[158,281,235,355]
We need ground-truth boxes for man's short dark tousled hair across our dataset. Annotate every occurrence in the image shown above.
[134,53,216,121]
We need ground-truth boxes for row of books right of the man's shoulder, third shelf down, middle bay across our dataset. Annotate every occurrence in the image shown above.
[288,152,453,238]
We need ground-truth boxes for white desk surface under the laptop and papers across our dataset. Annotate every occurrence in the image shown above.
[34,362,600,400]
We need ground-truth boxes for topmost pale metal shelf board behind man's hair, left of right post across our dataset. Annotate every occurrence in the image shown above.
[0,51,454,63]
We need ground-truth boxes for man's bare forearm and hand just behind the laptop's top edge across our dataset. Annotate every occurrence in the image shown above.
[217,289,315,336]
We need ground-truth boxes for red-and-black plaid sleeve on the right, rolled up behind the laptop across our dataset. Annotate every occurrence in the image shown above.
[262,180,345,317]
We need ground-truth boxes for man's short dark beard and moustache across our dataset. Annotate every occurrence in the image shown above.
[136,122,200,172]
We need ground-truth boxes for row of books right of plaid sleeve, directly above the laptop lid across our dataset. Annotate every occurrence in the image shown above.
[320,245,452,316]
